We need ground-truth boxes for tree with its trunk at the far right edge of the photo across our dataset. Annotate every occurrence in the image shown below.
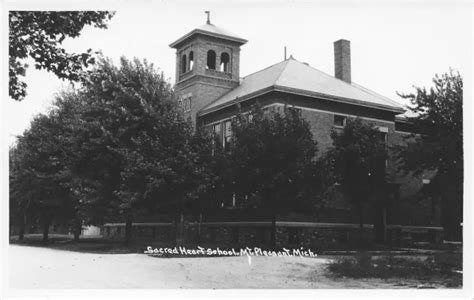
[399,70,464,239]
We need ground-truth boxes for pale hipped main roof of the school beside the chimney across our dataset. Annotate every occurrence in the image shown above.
[199,58,405,115]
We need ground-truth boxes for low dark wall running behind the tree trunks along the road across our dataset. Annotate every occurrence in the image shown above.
[101,222,443,249]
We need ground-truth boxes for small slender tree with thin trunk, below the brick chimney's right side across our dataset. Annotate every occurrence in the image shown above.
[325,118,387,241]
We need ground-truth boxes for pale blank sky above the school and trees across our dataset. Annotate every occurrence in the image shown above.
[2,1,472,144]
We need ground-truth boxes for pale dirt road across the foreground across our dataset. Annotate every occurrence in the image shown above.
[9,245,418,289]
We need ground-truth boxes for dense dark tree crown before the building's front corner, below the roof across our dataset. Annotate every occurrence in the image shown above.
[225,106,319,212]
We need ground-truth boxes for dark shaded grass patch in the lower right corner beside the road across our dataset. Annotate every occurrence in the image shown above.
[328,252,462,287]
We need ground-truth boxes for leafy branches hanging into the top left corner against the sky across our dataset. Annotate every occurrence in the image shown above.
[9,11,114,100]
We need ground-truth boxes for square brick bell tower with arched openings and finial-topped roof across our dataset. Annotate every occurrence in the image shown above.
[169,11,247,124]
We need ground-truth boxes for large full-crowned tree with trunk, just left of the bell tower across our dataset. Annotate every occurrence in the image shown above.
[52,58,211,243]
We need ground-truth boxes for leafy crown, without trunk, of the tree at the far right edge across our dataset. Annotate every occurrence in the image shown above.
[400,70,463,177]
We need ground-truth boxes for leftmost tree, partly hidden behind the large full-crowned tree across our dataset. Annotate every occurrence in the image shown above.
[10,115,72,241]
